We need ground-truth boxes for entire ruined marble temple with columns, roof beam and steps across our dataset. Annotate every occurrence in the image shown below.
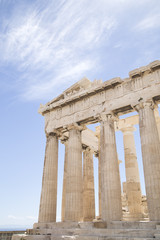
[13,60,160,240]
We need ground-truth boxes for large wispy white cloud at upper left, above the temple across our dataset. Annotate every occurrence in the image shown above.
[0,0,116,100]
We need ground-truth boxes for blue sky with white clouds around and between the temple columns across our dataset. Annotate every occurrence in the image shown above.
[0,0,160,228]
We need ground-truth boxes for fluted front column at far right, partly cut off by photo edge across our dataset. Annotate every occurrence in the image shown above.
[136,101,160,221]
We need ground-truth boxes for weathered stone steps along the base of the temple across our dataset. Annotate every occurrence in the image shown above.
[12,221,160,240]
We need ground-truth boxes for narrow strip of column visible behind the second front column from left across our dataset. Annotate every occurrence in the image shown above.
[61,140,68,222]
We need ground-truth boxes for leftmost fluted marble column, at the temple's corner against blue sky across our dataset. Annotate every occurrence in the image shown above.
[38,133,58,222]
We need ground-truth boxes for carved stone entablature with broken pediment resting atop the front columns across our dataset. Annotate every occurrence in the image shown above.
[39,61,160,132]
